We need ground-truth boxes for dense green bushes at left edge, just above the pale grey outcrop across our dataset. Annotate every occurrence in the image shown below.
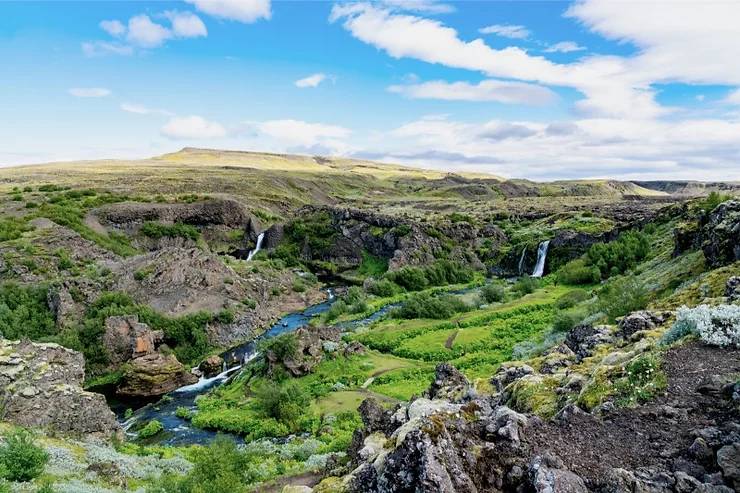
[0,283,57,341]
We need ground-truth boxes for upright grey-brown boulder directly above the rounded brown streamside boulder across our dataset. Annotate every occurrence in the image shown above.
[102,315,164,366]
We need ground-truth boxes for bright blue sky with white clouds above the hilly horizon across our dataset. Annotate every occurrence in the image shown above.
[0,0,740,181]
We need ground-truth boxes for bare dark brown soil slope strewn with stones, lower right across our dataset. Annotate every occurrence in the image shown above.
[530,342,740,478]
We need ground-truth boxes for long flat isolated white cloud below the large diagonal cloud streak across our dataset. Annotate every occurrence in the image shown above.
[388,80,557,106]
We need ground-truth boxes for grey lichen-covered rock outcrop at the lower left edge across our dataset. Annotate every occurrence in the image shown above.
[0,337,120,437]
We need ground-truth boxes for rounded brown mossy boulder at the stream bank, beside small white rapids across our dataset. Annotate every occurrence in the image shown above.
[118,353,198,397]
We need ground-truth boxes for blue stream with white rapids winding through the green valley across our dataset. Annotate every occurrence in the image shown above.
[112,287,486,446]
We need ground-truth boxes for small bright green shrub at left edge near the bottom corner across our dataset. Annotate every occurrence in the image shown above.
[0,430,49,483]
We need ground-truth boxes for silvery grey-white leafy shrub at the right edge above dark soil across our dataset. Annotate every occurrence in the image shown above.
[661,305,740,346]
